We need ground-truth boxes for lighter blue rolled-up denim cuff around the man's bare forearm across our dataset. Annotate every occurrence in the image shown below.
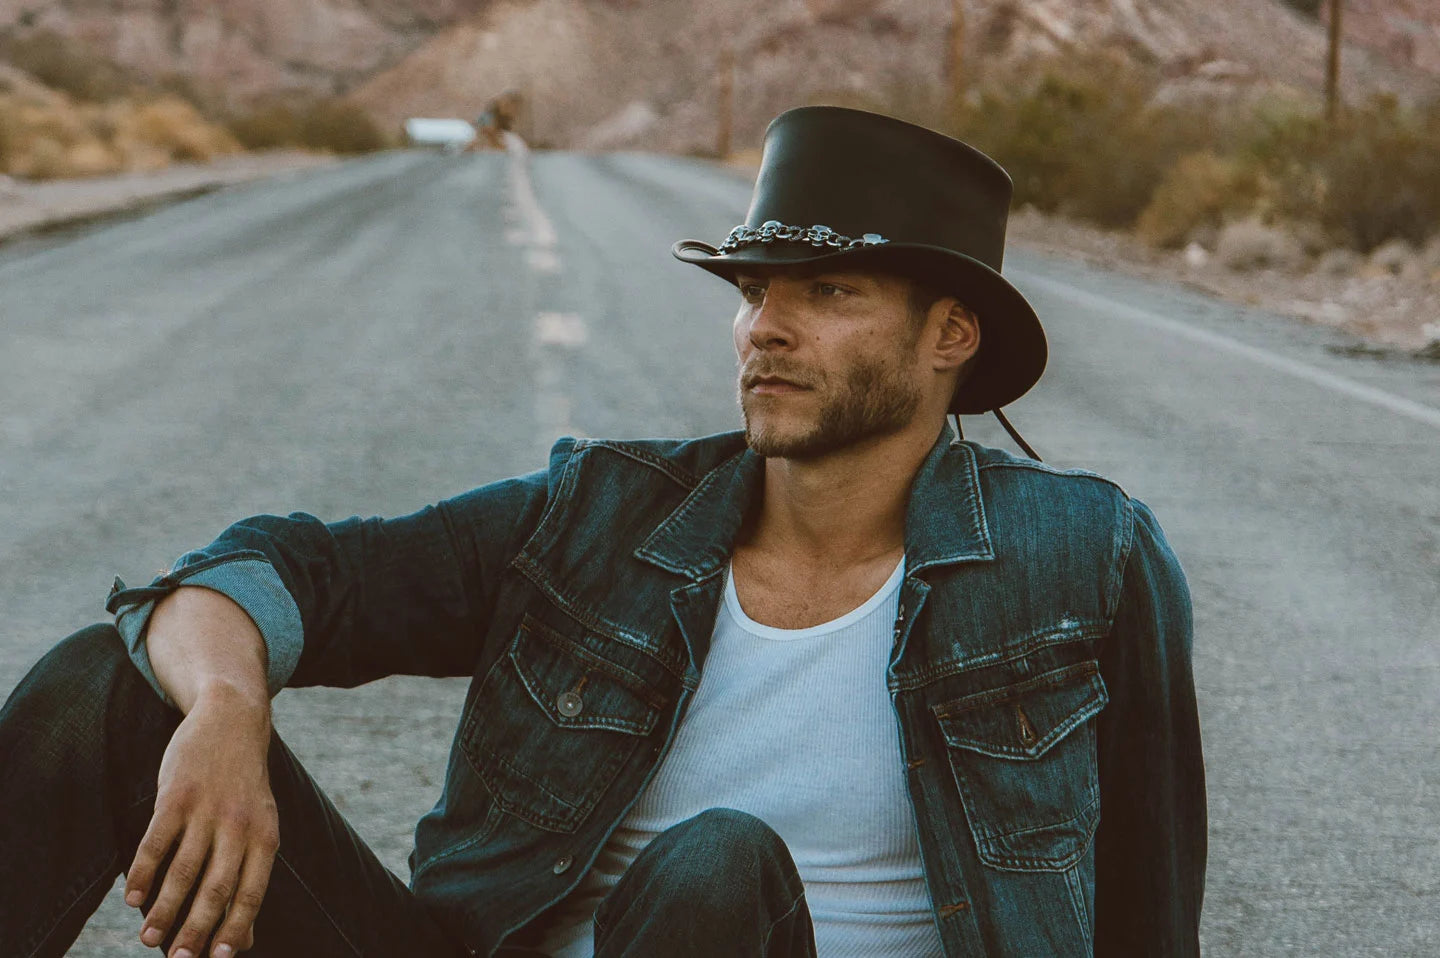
[108,552,304,707]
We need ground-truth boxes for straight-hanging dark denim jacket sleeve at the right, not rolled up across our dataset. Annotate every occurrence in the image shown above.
[1094,498,1207,958]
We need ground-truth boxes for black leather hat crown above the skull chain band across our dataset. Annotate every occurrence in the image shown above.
[746,107,1012,271]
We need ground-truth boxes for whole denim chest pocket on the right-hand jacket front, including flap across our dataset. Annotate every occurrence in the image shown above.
[932,661,1109,872]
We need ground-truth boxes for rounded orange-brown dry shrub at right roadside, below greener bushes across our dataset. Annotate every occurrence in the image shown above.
[1135,150,1266,248]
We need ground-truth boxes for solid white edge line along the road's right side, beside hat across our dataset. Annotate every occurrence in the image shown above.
[1008,269,1440,429]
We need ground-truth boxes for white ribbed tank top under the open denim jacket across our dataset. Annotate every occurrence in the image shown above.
[541,559,943,958]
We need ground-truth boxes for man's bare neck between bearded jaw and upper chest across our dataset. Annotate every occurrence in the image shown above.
[746,428,936,568]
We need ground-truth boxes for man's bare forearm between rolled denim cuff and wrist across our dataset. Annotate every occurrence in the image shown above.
[145,585,269,713]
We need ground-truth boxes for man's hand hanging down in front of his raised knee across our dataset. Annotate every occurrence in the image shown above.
[125,684,279,958]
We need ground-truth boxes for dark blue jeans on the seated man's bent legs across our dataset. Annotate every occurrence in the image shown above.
[0,624,815,958]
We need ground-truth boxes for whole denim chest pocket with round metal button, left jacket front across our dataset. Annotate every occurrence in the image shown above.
[461,615,662,831]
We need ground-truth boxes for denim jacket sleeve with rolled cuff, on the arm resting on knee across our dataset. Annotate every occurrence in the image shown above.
[107,438,575,694]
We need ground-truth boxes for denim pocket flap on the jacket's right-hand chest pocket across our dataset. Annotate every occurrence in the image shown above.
[932,661,1110,759]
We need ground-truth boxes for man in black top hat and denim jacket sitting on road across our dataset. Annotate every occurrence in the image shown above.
[0,107,1205,957]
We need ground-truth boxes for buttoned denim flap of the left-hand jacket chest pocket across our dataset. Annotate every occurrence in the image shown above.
[510,615,662,735]
